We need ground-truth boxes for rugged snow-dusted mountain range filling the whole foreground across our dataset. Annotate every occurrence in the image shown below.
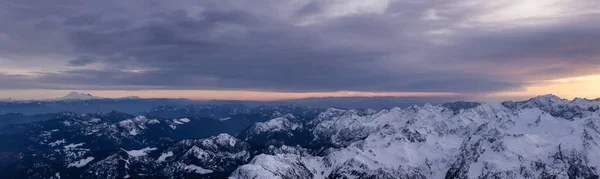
[0,95,600,179]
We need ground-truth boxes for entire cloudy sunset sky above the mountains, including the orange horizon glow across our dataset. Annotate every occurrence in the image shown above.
[0,0,600,100]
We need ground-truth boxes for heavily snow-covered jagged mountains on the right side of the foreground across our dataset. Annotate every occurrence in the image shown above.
[231,98,600,179]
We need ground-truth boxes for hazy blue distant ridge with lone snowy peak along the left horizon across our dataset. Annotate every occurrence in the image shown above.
[0,92,468,115]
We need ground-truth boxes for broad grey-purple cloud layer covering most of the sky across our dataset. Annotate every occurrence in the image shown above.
[0,0,600,92]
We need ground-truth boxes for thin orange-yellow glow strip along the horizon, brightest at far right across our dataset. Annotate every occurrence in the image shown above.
[0,74,600,101]
